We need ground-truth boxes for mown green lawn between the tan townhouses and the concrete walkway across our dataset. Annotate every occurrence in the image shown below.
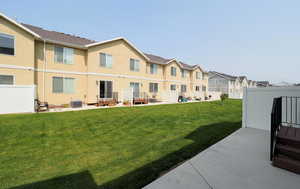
[0,100,242,189]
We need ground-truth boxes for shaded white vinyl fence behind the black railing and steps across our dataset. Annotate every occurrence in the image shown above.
[243,87,300,130]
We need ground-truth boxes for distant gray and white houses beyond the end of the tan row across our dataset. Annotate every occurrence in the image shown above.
[208,71,256,99]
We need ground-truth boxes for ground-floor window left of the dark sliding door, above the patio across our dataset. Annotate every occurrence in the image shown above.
[52,77,75,94]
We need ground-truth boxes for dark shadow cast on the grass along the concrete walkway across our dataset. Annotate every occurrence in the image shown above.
[10,122,241,189]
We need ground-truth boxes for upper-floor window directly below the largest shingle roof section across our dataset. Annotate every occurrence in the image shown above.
[54,46,74,64]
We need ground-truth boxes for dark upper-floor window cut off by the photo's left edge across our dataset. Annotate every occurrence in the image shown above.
[0,33,15,55]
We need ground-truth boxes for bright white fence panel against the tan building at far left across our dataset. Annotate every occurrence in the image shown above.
[0,85,35,114]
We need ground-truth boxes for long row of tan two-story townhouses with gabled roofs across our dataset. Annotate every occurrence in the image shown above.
[0,13,208,105]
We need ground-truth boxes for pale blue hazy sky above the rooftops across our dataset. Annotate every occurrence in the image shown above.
[0,0,300,83]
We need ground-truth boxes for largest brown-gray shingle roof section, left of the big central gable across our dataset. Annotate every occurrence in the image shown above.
[21,23,96,46]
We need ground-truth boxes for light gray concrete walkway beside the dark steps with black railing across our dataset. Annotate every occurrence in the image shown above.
[144,128,300,189]
